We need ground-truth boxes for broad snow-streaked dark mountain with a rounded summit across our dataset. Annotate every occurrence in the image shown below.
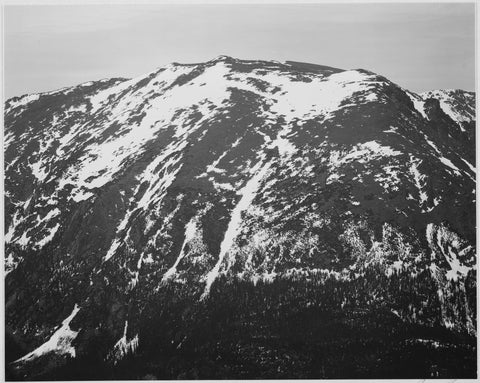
[4,56,476,378]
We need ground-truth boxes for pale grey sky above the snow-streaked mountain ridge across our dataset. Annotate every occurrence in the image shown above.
[3,3,475,98]
